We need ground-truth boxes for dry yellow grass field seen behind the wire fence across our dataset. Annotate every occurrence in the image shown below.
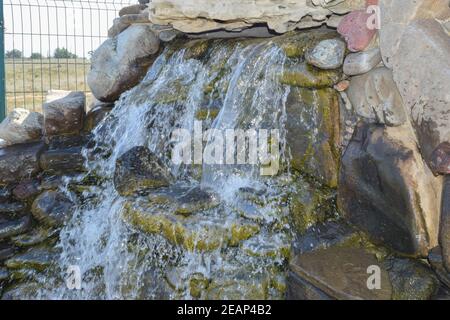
[5,58,93,112]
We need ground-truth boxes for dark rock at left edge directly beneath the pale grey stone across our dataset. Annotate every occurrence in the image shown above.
[0,142,45,185]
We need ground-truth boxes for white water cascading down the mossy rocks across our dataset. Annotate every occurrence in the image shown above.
[32,40,306,299]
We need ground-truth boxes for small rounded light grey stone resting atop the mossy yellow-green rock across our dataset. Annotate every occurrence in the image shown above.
[305,39,345,70]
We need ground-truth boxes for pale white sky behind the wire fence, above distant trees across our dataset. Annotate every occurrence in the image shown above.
[3,0,134,57]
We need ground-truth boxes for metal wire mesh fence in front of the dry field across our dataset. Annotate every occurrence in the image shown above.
[0,0,137,117]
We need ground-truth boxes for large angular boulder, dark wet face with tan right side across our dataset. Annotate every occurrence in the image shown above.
[338,123,442,257]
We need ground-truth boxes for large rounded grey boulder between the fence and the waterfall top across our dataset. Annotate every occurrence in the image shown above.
[87,25,159,102]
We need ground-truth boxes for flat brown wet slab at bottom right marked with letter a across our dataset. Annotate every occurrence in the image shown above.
[288,247,392,300]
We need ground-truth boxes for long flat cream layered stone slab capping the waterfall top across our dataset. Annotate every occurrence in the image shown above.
[149,0,365,33]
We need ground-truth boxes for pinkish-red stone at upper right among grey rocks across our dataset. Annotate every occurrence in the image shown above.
[337,10,377,52]
